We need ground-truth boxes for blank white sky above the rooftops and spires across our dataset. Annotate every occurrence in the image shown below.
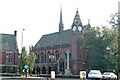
[0,0,120,50]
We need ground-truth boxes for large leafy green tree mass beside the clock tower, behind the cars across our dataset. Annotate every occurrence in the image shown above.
[83,26,116,70]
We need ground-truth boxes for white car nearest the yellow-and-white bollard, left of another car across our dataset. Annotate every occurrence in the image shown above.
[88,70,102,79]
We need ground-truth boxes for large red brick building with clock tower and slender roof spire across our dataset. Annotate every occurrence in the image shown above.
[33,9,90,74]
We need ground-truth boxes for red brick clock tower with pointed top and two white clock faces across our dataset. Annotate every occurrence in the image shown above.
[71,9,83,74]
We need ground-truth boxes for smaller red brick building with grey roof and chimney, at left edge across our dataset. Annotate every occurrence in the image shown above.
[0,31,19,73]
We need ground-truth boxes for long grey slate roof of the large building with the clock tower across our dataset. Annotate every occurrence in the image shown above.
[33,29,72,49]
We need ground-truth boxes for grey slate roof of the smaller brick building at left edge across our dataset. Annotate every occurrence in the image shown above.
[0,34,18,51]
